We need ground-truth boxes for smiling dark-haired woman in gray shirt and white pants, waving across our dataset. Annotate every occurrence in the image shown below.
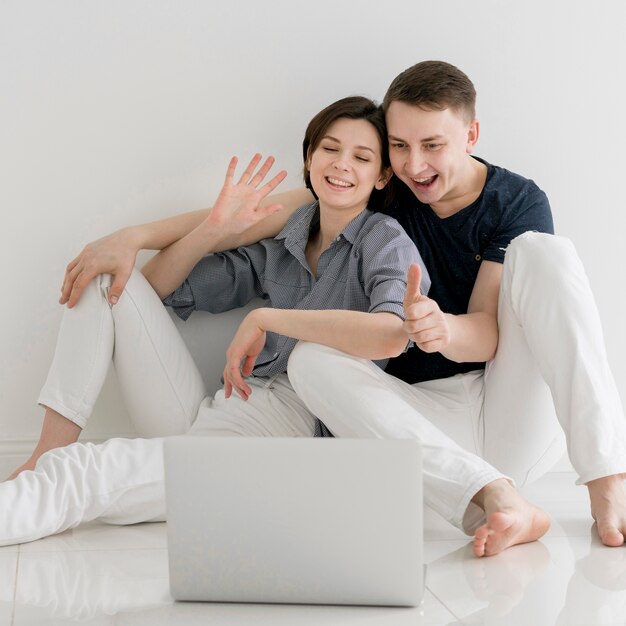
[0,97,428,545]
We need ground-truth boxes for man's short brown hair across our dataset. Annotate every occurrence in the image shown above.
[383,61,476,122]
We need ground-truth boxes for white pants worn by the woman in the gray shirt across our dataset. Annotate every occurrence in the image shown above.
[0,271,315,545]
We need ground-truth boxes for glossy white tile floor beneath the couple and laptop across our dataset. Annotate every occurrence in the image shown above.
[0,472,626,626]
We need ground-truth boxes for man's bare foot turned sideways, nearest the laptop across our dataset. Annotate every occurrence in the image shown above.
[472,478,550,556]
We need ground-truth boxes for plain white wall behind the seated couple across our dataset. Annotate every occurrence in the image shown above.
[0,0,626,469]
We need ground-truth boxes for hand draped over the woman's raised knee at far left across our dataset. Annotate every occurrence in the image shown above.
[59,229,139,309]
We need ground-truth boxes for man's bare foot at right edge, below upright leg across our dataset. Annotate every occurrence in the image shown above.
[587,474,626,547]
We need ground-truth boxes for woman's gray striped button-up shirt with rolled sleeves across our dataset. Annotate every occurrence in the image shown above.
[163,202,430,376]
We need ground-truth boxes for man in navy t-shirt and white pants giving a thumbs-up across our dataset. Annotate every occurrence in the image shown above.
[26,61,626,556]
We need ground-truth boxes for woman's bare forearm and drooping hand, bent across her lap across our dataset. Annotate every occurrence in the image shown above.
[224,308,408,400]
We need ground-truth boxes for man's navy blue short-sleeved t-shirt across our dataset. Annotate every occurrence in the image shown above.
[385,157,554,383]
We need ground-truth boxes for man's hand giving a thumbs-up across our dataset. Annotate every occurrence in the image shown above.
[403,264,450,352]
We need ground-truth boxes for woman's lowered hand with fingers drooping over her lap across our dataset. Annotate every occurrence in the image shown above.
[224,310,266,400]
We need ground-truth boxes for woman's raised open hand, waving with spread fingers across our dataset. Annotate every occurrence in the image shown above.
[207,154,287,234]
